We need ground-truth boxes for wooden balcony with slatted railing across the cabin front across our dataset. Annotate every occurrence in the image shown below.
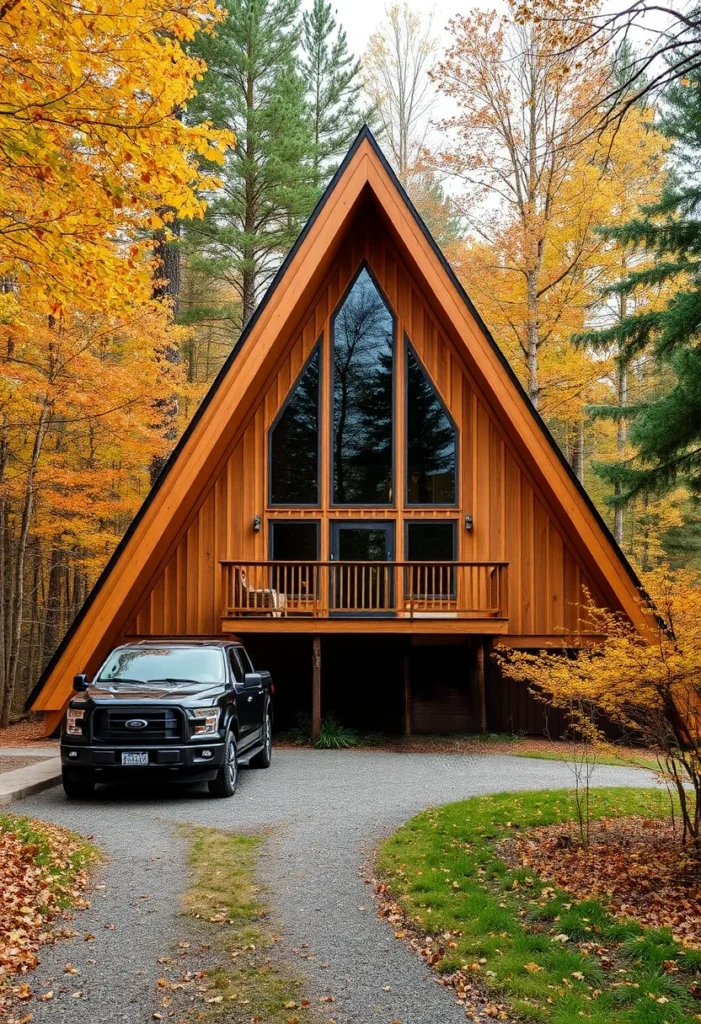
[220,561,509,633]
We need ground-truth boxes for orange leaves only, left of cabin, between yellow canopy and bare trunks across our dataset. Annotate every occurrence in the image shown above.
[0,303,190,582]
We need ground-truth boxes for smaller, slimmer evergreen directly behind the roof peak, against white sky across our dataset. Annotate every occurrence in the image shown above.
[302,0,373,182]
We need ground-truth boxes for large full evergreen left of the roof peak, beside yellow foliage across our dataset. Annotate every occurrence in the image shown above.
[182,0,317,327]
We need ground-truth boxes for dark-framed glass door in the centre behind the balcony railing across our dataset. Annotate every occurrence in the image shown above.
[330,520,394,615]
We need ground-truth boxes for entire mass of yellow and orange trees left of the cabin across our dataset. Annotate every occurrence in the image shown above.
[0,0,234,726]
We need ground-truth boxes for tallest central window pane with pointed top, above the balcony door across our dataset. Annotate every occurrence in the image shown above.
[333,268,394,505]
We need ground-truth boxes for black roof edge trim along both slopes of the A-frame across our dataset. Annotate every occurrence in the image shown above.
[25,125,643,710]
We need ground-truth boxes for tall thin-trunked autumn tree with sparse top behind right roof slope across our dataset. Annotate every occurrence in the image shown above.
[432,7,606,411]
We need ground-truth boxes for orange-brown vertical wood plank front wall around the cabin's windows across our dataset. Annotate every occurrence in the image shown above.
[126,205,605,636]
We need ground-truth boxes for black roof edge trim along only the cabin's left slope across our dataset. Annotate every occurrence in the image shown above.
[25,126,368,711]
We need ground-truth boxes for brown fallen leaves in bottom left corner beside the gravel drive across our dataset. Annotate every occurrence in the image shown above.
[0,814,96,1022]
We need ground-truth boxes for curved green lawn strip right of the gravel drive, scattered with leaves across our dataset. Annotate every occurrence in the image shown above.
[378,788,701,1024]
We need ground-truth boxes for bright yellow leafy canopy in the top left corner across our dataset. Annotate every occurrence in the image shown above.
[0,0,231,316]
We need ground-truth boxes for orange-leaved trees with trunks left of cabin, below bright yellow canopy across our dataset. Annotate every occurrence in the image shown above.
[0,302,185,727]
